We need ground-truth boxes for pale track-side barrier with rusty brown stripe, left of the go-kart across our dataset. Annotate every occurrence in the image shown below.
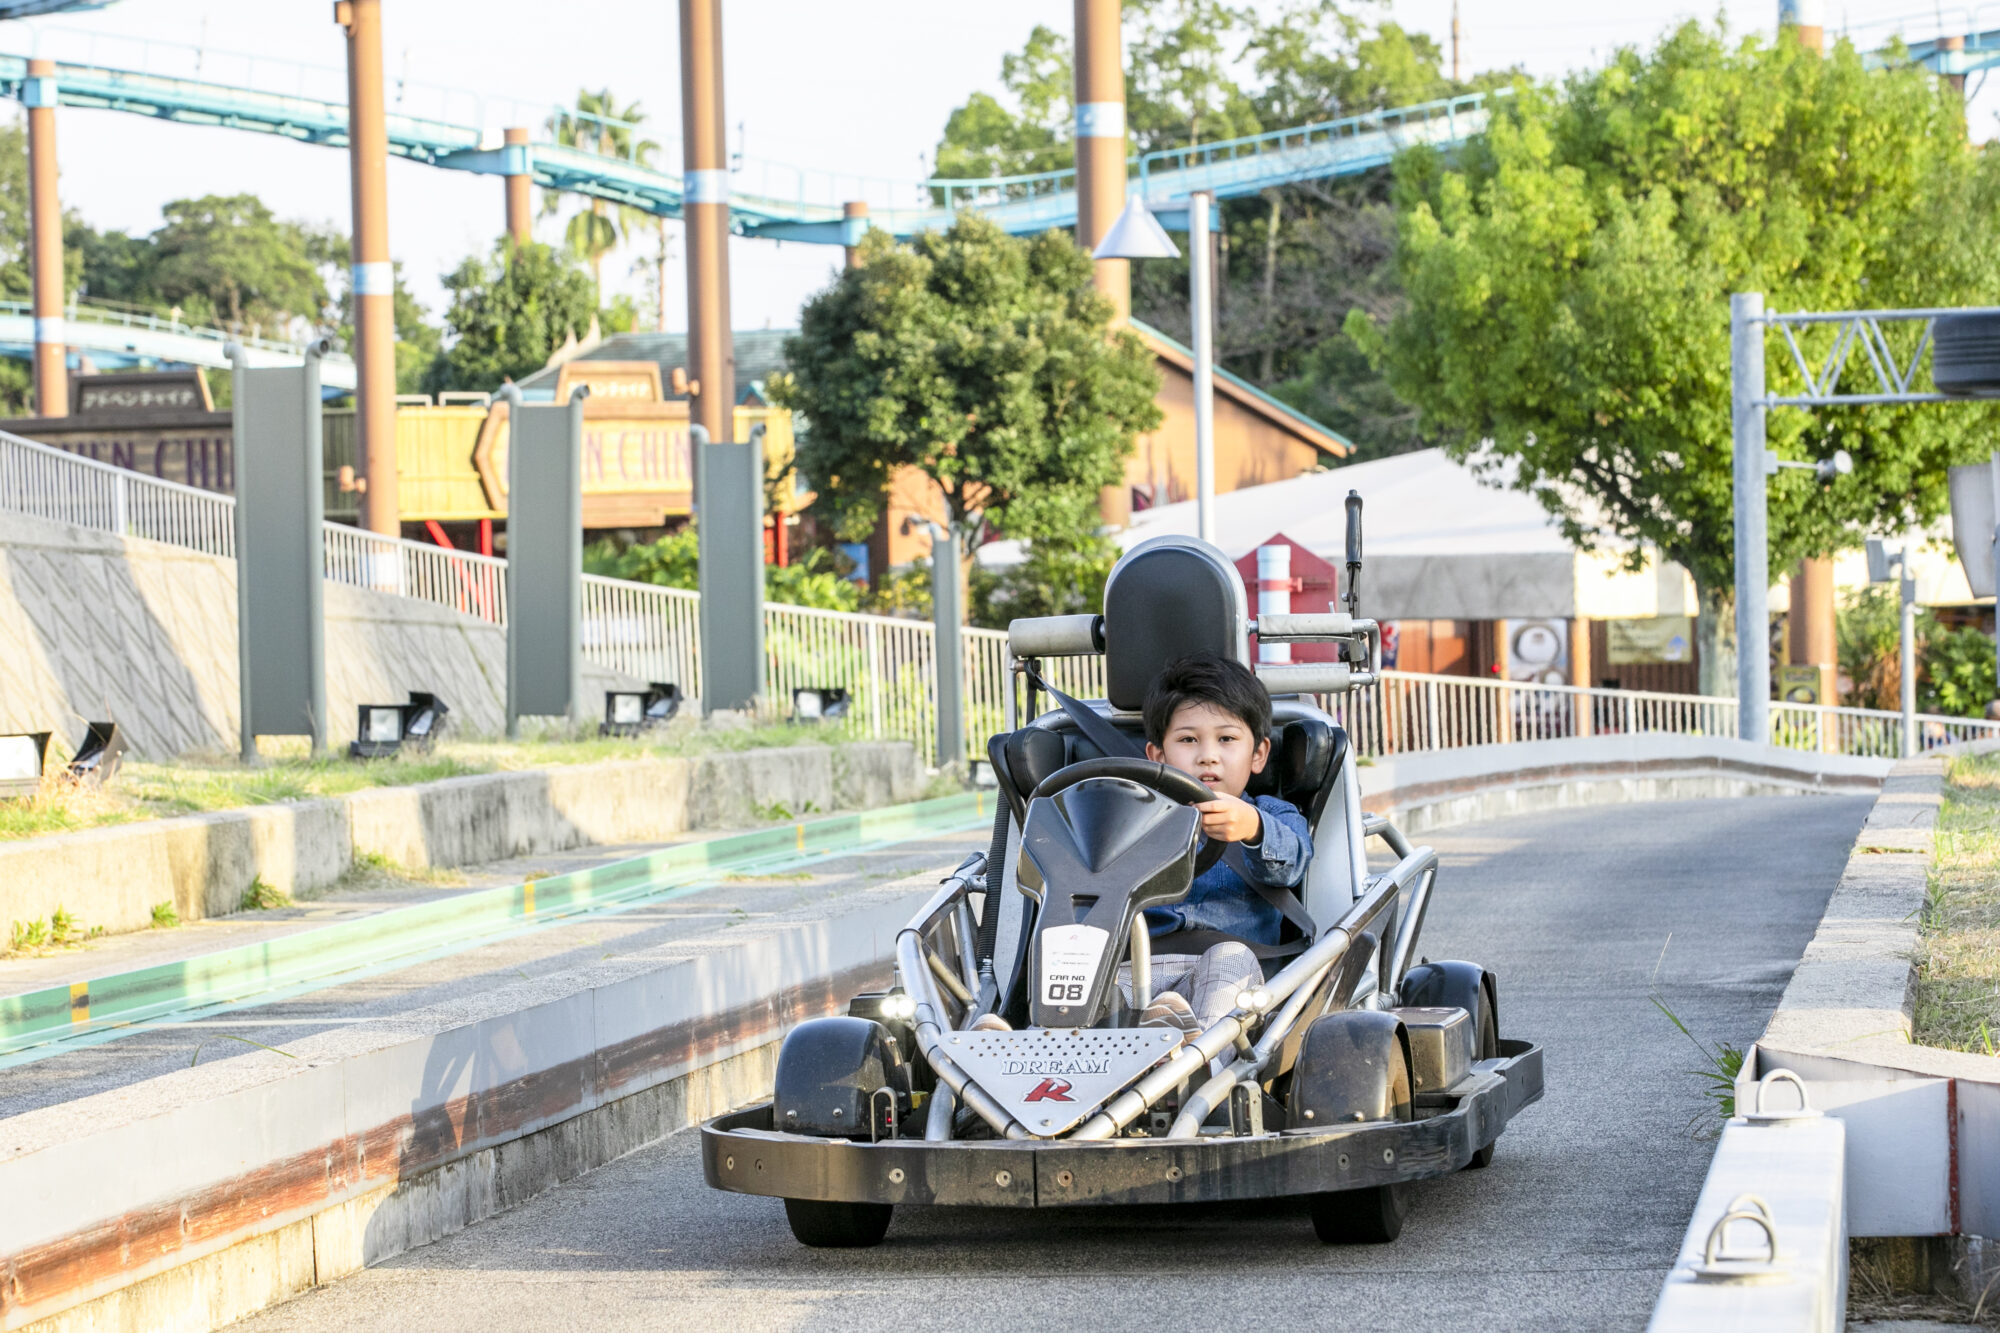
[0,877,936,1333]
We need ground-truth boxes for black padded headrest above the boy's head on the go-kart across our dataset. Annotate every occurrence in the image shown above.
[1104,536,1250,713]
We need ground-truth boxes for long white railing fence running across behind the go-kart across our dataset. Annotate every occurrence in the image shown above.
[0,422,2000,759]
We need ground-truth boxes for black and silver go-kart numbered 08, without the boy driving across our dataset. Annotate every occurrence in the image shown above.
[702,512,1542,1247]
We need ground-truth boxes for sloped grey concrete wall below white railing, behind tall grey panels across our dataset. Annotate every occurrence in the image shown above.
[0,514,638,759]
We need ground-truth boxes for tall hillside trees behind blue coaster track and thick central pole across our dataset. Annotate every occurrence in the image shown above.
[936,0,1480,458]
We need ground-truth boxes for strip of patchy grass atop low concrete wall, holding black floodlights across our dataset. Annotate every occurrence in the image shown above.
[0,723,856,841]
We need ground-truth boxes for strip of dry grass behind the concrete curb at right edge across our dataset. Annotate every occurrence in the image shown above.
[1914,755,2000,1055]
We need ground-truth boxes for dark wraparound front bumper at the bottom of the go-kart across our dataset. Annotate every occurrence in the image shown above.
[702,1041,1542,1209]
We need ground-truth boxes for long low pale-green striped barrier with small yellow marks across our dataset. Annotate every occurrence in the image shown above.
[0,791,996,1067]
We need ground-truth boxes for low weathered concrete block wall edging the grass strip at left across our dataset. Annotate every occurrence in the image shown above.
[0,741,924,933]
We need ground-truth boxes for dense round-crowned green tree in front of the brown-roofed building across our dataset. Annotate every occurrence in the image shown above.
[772,212,1160,554]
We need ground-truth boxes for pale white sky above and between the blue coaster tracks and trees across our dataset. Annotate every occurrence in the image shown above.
[0,0,2000,330]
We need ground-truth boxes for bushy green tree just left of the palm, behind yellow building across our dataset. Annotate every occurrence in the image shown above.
[426,240,596,392]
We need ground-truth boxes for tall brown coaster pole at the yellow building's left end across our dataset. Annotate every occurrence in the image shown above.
[334,0,402,536]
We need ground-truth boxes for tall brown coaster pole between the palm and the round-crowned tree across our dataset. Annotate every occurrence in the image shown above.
[680,0,736,444]
